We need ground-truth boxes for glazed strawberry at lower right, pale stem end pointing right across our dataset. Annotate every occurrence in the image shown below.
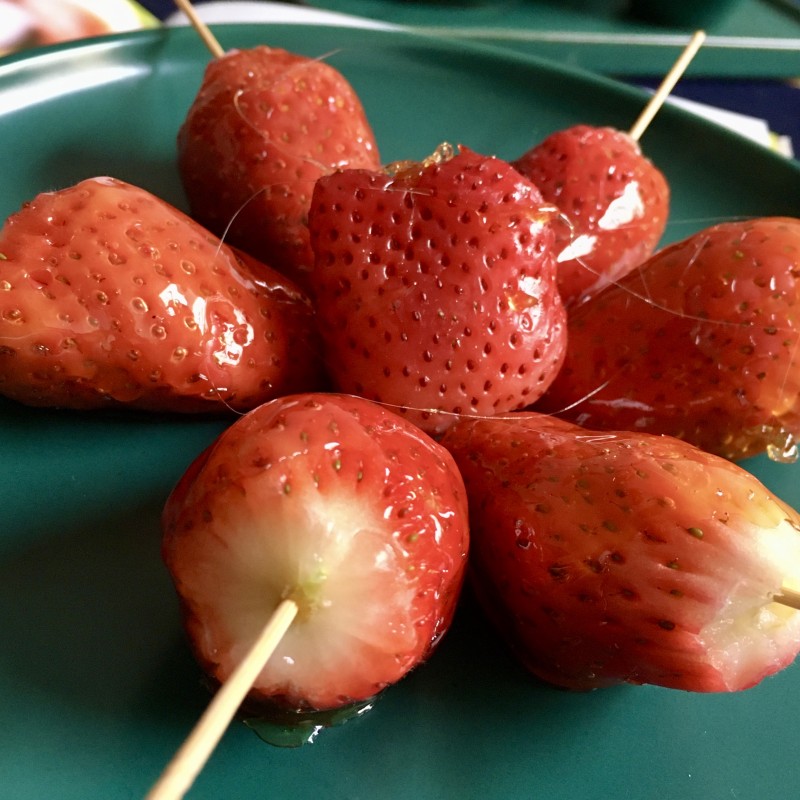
[443,412,800,692]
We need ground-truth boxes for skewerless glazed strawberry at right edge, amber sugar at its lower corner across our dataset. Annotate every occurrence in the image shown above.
[537,218,800,460]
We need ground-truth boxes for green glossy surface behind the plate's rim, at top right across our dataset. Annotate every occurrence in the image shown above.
[312,0,800,78]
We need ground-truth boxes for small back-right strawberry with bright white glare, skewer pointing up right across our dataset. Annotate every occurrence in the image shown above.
[513,125,669,305]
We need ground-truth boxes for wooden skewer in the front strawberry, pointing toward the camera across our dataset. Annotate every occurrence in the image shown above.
[145,600,298,800]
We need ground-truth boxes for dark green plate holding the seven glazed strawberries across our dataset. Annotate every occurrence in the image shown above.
[0,26,800,800]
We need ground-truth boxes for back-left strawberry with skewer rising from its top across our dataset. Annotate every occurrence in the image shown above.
[178,47,380,285]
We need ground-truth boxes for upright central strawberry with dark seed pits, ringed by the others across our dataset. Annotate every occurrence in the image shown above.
[309,145,566,430]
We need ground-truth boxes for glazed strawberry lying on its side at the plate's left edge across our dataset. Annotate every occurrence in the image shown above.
[0,177,321,412]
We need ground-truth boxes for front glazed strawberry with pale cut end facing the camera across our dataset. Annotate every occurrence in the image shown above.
[163,394,468,720]
